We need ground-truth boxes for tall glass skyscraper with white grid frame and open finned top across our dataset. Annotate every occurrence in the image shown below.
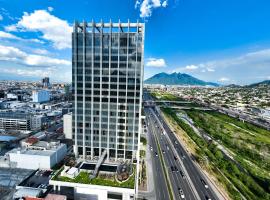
[72,21,144,160]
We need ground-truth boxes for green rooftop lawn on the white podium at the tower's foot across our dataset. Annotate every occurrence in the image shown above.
[53,169,135,189]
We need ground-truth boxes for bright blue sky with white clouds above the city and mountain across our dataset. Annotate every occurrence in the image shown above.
[0,0,270,84]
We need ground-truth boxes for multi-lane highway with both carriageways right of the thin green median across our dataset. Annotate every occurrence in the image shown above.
[144,94,218,200]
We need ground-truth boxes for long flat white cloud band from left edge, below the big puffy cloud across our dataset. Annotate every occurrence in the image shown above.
[0,45,71,68]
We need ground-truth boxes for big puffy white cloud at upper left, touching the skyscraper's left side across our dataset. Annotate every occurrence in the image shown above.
[5,10,72,49]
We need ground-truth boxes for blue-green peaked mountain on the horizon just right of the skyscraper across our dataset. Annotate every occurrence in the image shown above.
[144,72,219,86]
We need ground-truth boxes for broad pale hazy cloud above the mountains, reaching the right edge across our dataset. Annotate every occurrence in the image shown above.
[171,48,270,85]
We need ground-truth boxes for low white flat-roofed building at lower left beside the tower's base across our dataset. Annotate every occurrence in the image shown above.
[7,141,67,170]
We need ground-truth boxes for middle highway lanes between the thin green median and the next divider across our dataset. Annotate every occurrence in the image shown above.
[145,108,197,200]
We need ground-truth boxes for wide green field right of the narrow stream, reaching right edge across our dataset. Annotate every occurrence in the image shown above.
[187,110,270,193]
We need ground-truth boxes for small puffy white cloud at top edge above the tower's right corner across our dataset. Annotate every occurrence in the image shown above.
[135,0,168,18]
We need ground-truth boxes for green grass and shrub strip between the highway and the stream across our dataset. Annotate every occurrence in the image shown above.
[162,108,270,200]
